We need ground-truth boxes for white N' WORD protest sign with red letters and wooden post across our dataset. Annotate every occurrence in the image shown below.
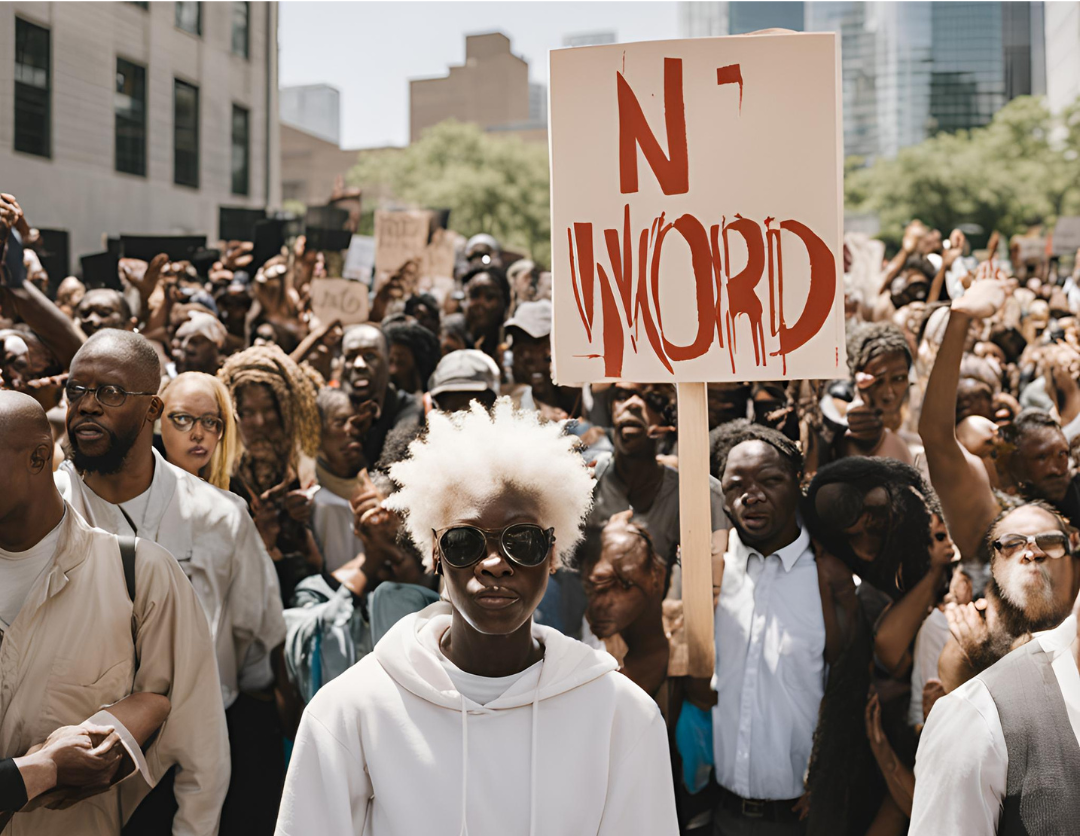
[549,32,847,676]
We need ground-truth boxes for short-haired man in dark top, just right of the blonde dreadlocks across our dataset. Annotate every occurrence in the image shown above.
[341,324,427,464]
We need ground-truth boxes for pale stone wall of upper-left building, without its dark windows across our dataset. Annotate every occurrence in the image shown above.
[0,2,281,266]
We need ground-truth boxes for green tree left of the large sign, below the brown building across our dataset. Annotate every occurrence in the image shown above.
[348,120,551,265]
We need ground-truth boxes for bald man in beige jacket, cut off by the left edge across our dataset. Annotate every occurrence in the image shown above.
[0,391,229,836]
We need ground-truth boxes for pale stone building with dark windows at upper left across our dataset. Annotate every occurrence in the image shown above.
[0,2,281,267]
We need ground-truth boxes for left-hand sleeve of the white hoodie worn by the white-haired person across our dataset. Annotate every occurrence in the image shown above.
[274,705,372,836]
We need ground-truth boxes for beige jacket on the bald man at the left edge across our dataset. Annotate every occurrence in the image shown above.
[0,505,229,836]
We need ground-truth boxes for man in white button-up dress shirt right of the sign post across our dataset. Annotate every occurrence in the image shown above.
[713,421,825,836]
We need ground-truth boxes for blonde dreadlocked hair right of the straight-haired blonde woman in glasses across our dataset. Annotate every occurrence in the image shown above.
[217,346,323,458]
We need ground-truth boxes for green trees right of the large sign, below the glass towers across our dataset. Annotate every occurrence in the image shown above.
[843,96,1080,247]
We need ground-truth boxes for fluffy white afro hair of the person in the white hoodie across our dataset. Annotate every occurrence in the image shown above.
[386,397,594,571]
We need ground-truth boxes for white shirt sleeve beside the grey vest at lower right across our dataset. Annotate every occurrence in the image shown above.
[908,679,1009,836]
